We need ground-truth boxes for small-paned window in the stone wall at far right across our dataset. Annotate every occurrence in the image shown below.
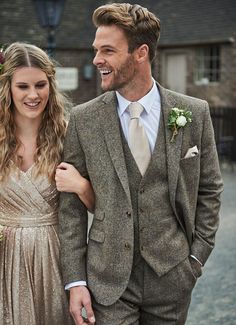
[195,45,220,85]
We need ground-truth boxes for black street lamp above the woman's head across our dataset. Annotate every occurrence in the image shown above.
[32,0,65,56]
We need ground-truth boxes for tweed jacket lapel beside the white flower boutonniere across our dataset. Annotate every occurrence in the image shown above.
[158,85,183,215]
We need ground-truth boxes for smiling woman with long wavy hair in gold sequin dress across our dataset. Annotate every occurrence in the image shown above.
[0,42,94,325]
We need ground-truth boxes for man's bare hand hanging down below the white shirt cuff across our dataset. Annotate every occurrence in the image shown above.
[70,286,95,325]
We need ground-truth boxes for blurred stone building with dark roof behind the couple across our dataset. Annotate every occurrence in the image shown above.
[0,0,236,160]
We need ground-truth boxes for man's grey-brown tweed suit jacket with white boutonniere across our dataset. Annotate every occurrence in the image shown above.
[59,84,223,305]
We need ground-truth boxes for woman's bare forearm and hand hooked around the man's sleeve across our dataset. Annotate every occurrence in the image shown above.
[55,162,95,213]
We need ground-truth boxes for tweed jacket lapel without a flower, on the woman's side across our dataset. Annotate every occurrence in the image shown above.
[98,92,131,204]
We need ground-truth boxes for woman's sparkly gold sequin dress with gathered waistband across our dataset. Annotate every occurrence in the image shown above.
[0,166,72,325]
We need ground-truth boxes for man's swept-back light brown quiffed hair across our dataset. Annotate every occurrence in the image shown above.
[93,3,160,62]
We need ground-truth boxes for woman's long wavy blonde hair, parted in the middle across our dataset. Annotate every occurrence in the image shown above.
[0,42,71,181]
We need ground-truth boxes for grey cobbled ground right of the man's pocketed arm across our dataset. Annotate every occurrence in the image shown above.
[186,168,236,325]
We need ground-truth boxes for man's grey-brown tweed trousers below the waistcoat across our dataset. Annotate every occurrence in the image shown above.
[93,258,197,325]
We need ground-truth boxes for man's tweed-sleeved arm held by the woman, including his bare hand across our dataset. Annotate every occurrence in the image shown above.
[59,112,95,325]
